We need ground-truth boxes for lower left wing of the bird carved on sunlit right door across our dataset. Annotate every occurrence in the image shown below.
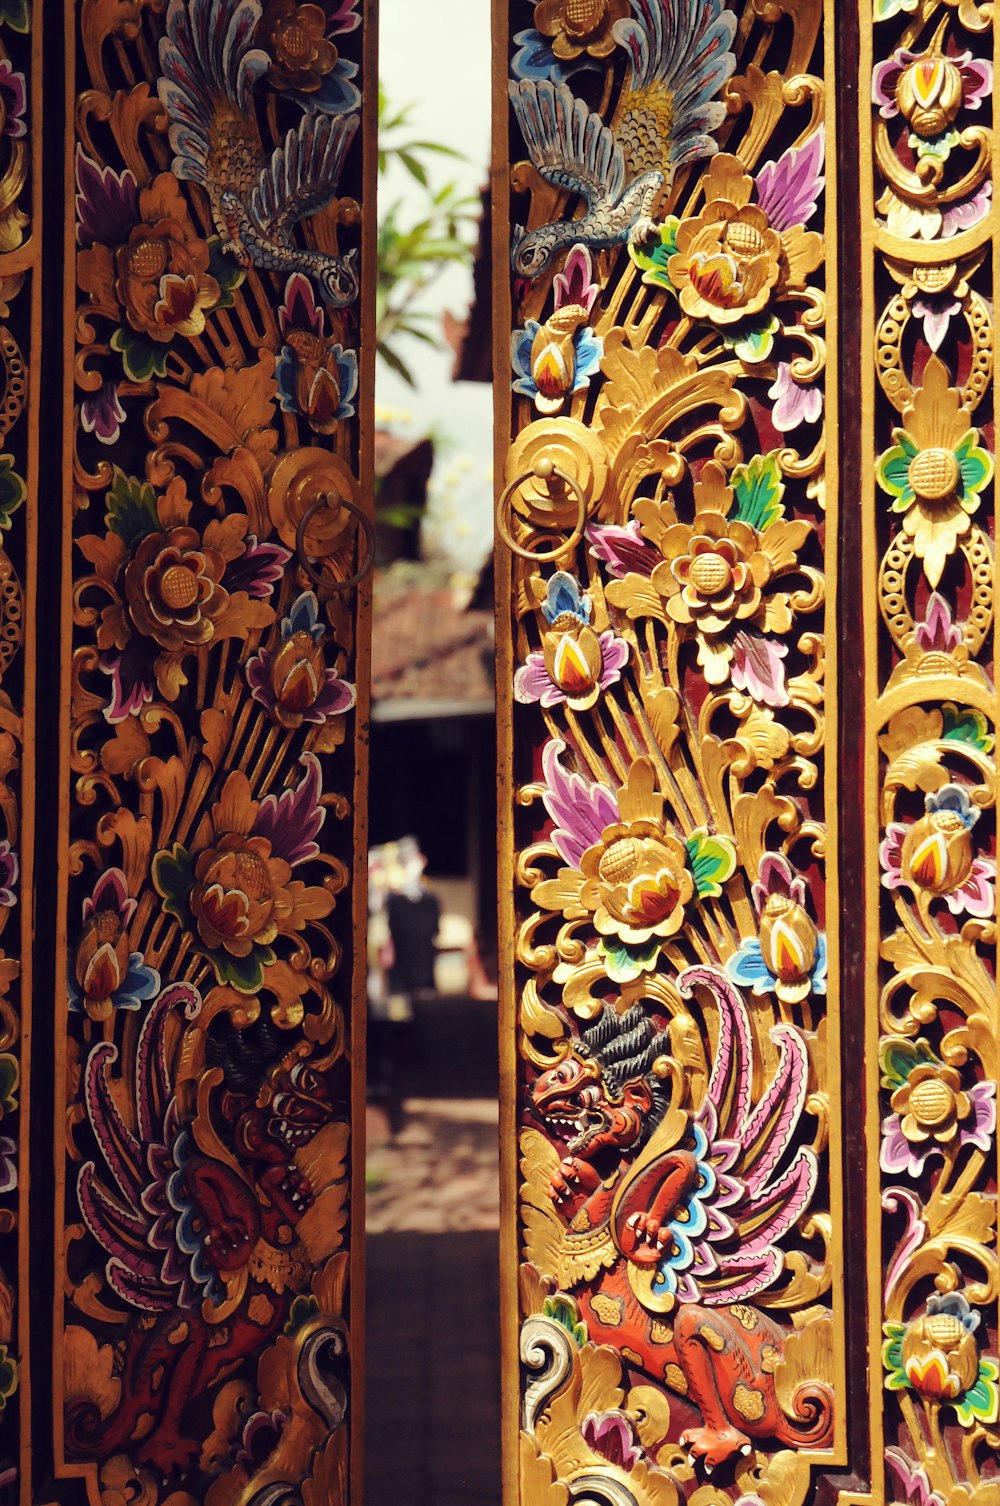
[509,80,625,209]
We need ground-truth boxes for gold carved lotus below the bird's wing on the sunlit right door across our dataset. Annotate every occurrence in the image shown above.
[667,152,822,325]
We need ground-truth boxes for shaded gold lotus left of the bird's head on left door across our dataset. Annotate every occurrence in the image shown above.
[114,173,221,342]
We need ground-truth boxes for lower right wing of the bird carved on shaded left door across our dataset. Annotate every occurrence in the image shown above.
[250,113,358,239]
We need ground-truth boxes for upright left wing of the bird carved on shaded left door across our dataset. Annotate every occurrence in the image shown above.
[157,0,270,184]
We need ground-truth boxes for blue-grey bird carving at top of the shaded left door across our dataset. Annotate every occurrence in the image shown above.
[157,0,358,309]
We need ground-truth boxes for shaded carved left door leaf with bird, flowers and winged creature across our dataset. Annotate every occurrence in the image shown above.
[54,0,375,1506]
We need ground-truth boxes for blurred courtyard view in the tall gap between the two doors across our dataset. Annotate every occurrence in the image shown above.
[366,0,500,1506]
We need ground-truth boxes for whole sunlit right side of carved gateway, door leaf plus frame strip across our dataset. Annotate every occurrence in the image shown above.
[494,0,1000,1506]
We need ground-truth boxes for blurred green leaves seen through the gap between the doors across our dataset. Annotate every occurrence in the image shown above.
[375,89,479,387]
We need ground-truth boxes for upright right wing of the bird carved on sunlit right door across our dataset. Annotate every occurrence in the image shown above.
[611,0,736,181]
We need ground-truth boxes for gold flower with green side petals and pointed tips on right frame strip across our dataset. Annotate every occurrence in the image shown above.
[877,355,994,587]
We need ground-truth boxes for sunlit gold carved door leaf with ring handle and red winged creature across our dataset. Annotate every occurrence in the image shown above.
[495,0,846,1506]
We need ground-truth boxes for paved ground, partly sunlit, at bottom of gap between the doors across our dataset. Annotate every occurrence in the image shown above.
[366,1074,500,1506]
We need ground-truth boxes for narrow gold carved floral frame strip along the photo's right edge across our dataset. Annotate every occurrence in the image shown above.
[861,0,1000,1506]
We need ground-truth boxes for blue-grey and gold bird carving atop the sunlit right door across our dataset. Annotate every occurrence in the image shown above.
[509,0,736,279]
